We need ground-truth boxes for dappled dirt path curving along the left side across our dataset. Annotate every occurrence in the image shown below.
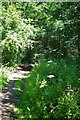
[0,65,30,120]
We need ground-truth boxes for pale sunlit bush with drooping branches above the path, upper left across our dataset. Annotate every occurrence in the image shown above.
[2,5,36,65]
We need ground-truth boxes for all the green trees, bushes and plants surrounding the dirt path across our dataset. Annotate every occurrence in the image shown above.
[0,2,80,120]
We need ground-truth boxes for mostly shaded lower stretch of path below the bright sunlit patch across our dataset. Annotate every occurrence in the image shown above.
[1,78,26,120]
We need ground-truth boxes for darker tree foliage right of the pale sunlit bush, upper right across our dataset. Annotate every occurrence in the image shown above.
[16,2,79,60]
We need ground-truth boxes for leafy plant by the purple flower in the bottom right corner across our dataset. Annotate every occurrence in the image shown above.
[54,90,80,120]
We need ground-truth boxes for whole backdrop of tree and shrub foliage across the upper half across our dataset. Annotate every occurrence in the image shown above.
[1,2,79,65]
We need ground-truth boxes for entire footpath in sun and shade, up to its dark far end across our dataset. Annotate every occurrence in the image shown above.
[0,65,32,120]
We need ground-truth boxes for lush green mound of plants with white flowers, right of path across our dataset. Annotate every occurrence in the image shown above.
[15,60,78,119]
